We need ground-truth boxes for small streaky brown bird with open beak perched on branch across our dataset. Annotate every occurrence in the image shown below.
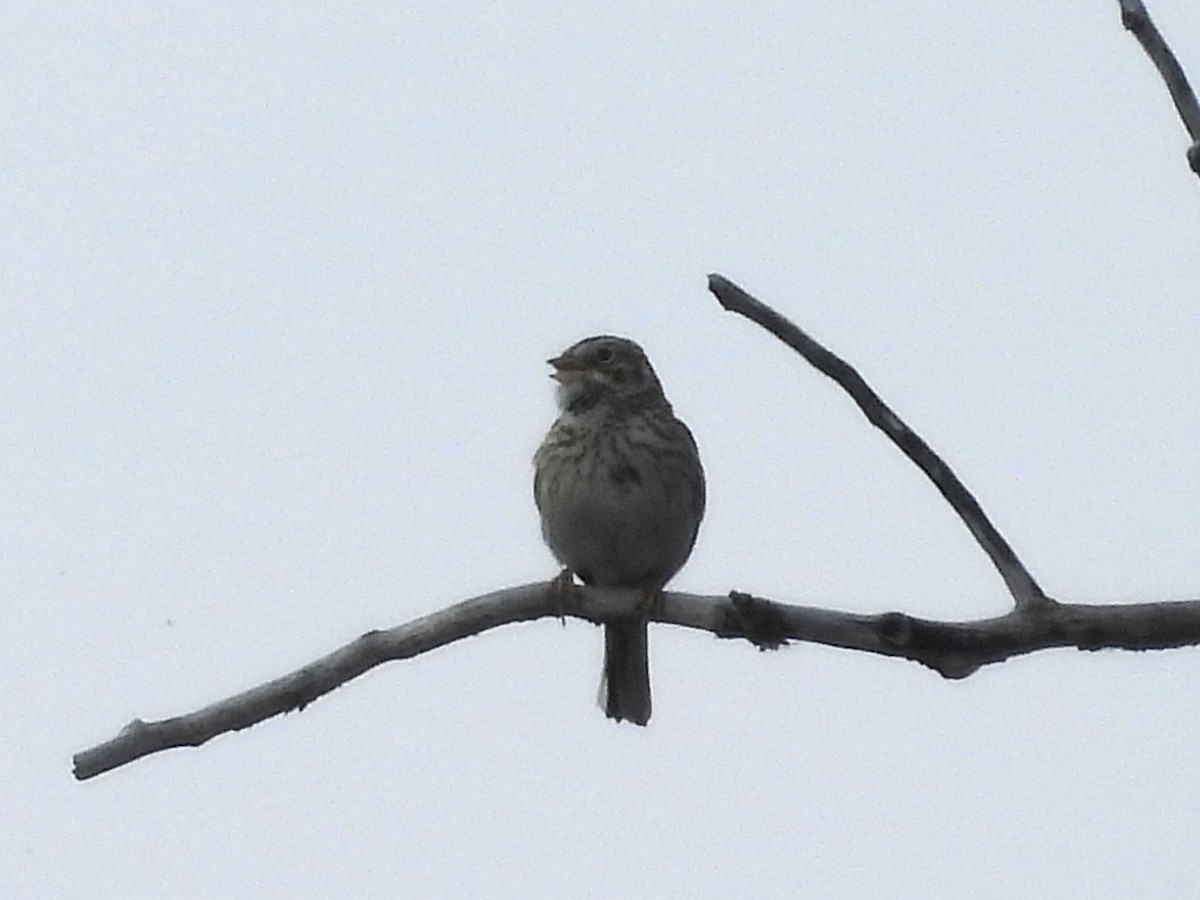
[534,335,704,725]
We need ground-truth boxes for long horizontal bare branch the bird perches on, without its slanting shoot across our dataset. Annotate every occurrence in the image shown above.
[74,582,1200,781]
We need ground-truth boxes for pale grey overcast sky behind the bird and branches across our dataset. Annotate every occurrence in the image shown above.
[9,0,1200,898]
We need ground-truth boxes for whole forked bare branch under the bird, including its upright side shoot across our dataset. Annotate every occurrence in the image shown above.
[74,275,1200,780]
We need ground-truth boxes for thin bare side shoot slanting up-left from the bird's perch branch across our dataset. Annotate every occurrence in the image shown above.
[708,274,1054,611]
